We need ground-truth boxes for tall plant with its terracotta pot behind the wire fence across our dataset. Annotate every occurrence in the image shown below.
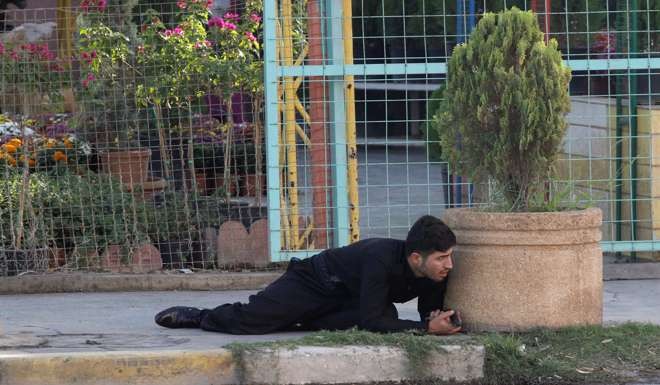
[77,0,151,186]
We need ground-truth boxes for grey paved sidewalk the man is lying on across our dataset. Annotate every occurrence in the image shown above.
[0,280,660,352]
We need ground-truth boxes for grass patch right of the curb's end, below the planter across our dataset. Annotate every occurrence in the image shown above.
[477,323,660,385]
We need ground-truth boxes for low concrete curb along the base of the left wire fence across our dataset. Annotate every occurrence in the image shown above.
[0,272,282,294]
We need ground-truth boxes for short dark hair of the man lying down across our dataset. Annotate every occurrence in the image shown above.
[406,215,456,257]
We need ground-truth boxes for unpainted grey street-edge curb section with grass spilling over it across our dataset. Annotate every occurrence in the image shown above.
[242,345,485,384]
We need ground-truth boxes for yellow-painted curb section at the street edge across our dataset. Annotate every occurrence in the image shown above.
[0,349,238,385]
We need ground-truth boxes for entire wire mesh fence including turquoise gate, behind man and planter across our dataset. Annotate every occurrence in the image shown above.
[0,0,660,276]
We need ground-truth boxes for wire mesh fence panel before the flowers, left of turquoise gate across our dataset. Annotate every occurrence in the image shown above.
[0,0,279,276]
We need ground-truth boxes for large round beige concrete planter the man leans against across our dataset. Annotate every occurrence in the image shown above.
[444,208,603,331]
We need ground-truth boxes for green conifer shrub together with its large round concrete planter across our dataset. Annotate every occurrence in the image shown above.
[436,8,602,330]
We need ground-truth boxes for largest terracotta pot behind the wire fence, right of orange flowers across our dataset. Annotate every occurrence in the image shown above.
[100,148,151,185]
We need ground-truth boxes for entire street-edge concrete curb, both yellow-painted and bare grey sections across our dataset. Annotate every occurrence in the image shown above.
[0,345,485,385]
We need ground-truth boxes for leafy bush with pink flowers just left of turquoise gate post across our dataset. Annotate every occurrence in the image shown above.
[137,0,261,128]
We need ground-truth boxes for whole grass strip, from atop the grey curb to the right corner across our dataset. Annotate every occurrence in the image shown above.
[227,323,660,385]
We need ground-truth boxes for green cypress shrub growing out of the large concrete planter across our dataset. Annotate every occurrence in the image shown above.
[435,7,571,211]
